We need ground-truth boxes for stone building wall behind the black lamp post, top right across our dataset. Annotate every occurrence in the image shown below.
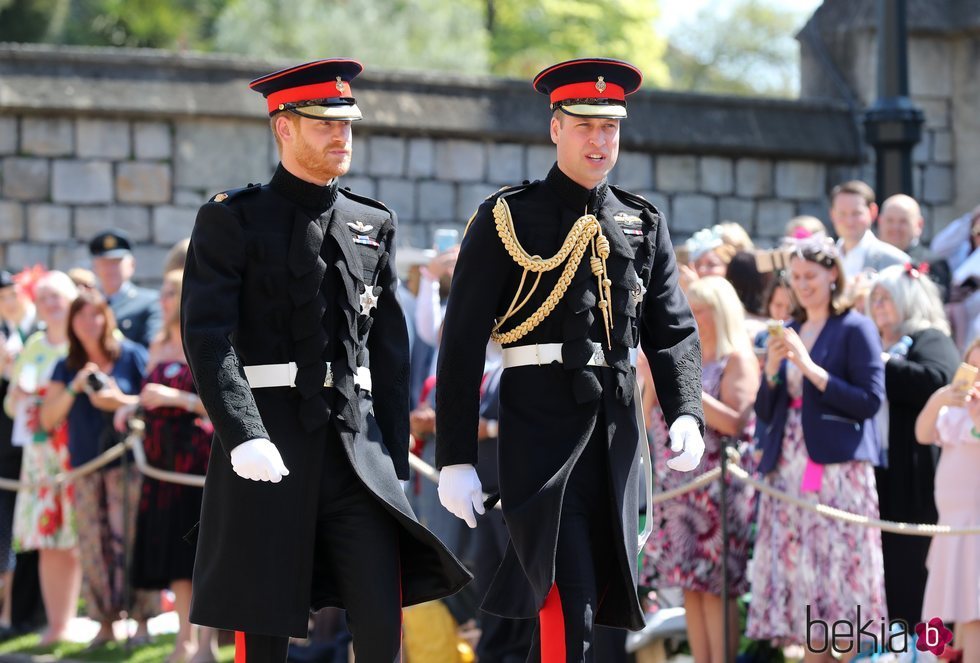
[799,0,980,235]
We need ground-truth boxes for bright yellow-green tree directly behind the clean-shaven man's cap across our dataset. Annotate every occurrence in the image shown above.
[487,0,669,85]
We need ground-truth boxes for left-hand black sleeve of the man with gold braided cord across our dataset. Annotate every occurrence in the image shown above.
[436,198,514,469]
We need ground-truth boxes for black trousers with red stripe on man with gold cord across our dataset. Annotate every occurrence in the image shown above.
[527,436,614,663]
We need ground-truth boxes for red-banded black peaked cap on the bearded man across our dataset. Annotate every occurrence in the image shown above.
[248,58,364,121]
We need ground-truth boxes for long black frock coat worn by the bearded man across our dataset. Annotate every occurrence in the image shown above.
[181,165,470,637]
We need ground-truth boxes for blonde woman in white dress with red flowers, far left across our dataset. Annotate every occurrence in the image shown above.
[4,272,82,645]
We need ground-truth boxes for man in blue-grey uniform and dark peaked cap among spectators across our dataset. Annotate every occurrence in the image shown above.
[88,229,163,347]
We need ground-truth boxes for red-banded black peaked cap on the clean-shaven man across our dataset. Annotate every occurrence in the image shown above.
[532,58,643,120]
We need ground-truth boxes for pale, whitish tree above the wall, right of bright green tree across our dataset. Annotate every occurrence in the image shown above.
[665,0,805,97]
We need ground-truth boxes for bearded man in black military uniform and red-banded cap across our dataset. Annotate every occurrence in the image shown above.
[182,59,470,663]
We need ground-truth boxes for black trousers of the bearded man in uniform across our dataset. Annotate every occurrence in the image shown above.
[235,434,401,663]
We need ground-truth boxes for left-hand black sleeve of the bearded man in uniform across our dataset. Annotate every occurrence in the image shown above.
[180,203,269,455]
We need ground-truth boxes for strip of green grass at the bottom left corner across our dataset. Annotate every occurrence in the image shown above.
[0,633,235,663]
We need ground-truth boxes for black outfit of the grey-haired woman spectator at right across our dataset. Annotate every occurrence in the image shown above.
[875,329,960,624]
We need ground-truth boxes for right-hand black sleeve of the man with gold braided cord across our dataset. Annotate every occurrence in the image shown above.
[640,210,704,433]
